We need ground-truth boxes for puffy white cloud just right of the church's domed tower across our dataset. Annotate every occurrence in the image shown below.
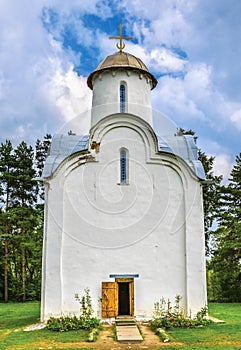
[152,59,241,146]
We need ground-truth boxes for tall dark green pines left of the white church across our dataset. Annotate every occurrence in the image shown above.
[0,135,51,302]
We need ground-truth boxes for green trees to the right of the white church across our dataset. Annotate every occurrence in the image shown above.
[178,129,241,302]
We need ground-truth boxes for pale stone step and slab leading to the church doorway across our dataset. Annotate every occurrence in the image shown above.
[116,318,143,344]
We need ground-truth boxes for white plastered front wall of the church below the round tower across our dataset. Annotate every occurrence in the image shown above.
[42,115,206,319]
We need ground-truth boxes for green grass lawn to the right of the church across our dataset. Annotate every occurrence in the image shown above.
[168,303,241,350]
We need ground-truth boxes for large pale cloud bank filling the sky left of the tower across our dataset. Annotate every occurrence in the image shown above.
[0,0,94,143]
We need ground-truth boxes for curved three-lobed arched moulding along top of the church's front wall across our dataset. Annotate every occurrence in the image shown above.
[45,113,203,186]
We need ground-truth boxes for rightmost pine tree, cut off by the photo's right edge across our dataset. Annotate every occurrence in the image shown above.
[212,153,241,302]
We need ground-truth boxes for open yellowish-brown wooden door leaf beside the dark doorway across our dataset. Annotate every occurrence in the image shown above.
[102,282,118,318]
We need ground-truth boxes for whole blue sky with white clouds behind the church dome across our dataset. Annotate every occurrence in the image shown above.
[0,0,241,177]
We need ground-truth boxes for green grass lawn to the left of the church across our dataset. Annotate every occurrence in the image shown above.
[0,302,90,350]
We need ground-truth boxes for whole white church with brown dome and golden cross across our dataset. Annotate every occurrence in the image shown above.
[41,26,207,321]
